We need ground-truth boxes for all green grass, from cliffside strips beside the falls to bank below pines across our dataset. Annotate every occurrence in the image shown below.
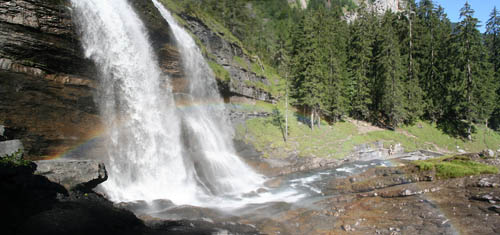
[160,0,500,158]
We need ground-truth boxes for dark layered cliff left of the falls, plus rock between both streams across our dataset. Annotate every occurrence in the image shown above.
[0,0,176,159]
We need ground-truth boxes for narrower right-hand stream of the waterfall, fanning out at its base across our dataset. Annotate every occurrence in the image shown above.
[153,0,263,195]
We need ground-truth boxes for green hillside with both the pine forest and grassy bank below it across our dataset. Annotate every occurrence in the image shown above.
[163,0,500,158]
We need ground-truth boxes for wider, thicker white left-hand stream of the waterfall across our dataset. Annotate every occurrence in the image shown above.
[72,0,199,203]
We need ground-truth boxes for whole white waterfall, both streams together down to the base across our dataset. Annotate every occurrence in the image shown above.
[71,0,263,205]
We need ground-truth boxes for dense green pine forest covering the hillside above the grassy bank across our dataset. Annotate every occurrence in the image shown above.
[178,0,500,139]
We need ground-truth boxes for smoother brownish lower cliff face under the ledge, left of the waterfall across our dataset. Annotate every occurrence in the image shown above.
[0,70,101,158]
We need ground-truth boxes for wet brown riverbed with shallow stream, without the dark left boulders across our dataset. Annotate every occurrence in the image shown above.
[113,151,500,234]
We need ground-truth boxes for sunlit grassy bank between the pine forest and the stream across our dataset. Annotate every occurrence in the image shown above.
[231,102,500,159]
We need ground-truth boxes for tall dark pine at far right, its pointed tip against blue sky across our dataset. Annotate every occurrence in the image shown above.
[449,2,494,140]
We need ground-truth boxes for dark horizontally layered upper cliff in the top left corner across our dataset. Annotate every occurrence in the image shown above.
[0,0,94,75]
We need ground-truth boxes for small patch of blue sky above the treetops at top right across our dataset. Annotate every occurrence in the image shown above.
[434,0,500,33]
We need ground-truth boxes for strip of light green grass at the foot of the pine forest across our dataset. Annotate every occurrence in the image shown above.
[237,103,500,158]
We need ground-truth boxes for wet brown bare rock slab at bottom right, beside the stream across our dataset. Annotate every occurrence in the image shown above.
[251,168,500,234]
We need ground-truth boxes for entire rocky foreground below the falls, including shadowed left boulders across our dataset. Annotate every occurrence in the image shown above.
[0,140,500,234]
